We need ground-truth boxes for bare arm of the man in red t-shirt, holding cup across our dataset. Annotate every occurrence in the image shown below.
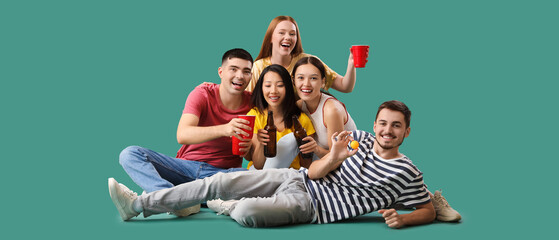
[177,113,252,145]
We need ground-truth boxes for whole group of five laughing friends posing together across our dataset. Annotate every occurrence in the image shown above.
[109,16,461,228]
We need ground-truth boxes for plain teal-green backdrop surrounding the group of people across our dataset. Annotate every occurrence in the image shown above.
[0,0,559,239]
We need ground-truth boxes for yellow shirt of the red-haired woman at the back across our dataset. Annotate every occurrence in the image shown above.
[250,53,338,92]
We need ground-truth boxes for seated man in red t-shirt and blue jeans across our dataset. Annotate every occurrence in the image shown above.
[119,48,253,216]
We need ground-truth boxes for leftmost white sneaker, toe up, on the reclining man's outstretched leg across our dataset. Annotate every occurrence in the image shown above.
[109,178,140,221]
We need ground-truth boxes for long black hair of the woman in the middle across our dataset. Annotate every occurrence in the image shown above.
[250,64,301,128]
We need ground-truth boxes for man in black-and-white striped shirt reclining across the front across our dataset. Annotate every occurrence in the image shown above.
[109,101,435,228]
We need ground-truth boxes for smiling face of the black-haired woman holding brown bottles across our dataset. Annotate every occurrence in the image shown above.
[262,71,285,110]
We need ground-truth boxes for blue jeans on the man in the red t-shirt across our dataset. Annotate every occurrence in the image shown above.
[119,146,246,193]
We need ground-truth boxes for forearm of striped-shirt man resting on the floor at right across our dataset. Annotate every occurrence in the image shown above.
[378,202,436,228]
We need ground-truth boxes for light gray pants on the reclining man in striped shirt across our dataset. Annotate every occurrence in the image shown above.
[138,169,315,227]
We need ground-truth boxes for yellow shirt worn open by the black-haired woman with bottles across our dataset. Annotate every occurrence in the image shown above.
[247,108,315,169]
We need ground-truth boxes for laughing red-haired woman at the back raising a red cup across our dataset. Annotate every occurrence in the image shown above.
[247,16,355,93]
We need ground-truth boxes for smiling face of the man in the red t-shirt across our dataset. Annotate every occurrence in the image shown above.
[218,58,252,94]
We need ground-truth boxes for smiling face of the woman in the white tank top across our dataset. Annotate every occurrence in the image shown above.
[293,63,325,102]
